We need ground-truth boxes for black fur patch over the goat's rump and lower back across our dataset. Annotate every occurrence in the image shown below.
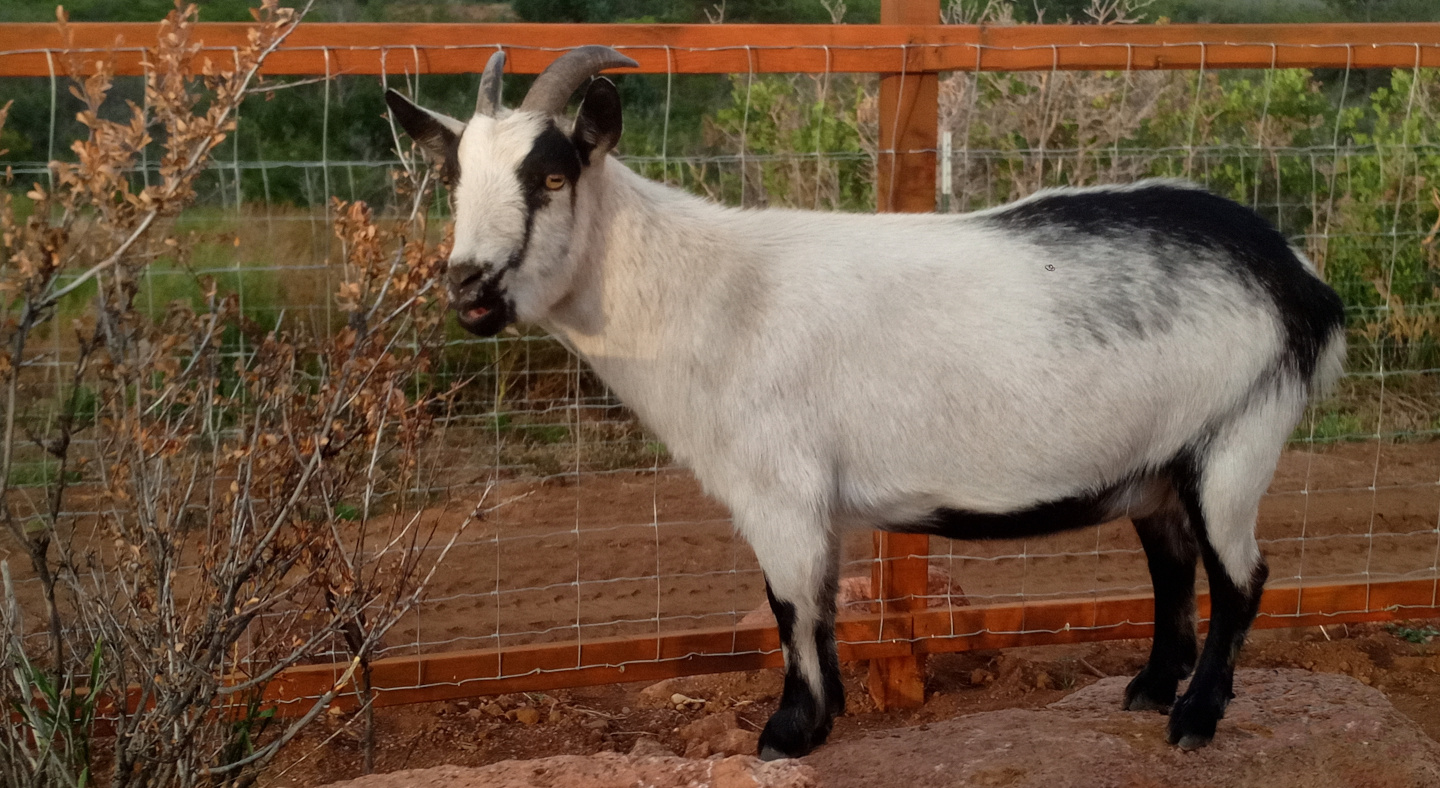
[988,183,1345,379]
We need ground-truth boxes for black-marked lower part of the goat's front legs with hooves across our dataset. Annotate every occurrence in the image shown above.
[759,567,845,761]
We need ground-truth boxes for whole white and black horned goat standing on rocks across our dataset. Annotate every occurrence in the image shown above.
[386,46,1345,758]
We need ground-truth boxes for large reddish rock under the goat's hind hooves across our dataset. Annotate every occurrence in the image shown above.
[805,670,1440,788]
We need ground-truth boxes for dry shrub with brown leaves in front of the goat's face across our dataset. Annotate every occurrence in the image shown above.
[0,0,478,787]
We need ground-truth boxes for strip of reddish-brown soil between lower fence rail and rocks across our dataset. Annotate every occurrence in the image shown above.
[262,619,1440,788]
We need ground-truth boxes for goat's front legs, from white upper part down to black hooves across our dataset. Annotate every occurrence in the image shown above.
[740,516,845,761]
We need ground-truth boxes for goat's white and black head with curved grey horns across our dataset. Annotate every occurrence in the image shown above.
[384,46,638,337]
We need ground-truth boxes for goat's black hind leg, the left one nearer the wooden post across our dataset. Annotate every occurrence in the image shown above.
[1125,506,1200,712]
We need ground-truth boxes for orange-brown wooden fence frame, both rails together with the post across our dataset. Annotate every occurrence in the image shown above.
[0,12,1440,712]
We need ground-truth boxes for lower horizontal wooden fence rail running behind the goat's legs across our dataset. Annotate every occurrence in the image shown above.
[266,581,1440,715]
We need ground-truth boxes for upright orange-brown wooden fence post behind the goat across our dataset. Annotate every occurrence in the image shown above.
[868,0,940,710]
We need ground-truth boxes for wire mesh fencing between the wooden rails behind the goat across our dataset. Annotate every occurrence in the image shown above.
[0,29,1440,705]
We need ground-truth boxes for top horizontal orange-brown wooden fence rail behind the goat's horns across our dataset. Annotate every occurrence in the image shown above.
[0,22,1440,76]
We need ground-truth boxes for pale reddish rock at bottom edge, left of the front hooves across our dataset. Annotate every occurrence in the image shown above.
[316,752,819,788]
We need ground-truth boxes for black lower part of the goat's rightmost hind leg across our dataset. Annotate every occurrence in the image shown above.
[1169,495,1270,749]
